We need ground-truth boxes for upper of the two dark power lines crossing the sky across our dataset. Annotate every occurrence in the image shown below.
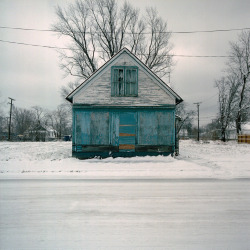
[0,26,250,34]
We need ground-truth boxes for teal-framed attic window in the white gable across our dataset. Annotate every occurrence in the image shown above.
[111,66,138,96]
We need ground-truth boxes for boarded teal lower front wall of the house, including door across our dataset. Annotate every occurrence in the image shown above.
[73,108,175,156]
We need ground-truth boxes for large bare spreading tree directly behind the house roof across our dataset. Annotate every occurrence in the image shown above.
[53,0,172,95]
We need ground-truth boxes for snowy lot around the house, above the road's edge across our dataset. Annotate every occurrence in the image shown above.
[0,140,250,179]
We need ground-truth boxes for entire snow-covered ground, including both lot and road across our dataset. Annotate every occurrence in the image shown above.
[0,141,250,250]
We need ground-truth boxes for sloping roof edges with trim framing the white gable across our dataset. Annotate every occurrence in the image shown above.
[66,48,183,104]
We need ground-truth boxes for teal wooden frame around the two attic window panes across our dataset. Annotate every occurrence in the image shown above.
[111,66,138,97]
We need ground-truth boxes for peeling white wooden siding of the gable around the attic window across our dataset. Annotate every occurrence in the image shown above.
[73,53,175,106]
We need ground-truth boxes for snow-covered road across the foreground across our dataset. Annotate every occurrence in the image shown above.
[0,179,250,250]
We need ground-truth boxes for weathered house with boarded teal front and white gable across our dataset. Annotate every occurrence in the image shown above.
[66,48,182,159]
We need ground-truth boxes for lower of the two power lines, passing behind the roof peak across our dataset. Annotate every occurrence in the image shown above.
[0,39,230,58]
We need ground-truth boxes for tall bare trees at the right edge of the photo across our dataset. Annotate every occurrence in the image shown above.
[216,31,250,140]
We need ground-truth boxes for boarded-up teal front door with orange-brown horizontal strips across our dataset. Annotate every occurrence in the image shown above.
[119,112,136,152]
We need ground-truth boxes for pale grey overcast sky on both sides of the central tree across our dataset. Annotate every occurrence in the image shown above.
[0,0,250,124]
